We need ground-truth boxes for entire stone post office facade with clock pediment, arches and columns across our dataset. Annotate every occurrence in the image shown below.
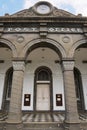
[0,1,87,130]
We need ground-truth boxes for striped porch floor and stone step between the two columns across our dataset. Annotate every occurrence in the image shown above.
[22,112,64,130]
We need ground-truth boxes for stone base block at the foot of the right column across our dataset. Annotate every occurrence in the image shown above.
[64,123,81,130]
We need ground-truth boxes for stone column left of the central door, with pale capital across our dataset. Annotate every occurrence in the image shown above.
[7,61,25,130]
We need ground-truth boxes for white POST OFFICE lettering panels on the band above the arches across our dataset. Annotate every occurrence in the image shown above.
[4,27,83,33]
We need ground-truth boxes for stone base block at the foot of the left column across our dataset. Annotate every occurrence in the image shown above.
[6,123,23,130]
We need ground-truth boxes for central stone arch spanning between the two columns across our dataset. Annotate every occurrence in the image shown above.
[21,38,66,58]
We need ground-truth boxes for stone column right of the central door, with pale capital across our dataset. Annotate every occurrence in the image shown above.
[62,60,80,130]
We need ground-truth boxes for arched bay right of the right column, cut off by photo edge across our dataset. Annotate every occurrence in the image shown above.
[71,40,87,111]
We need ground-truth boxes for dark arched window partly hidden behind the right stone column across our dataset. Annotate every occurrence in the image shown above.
[74,68,84,110]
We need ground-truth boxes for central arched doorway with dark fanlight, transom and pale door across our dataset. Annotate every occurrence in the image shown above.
[34,66,53,111]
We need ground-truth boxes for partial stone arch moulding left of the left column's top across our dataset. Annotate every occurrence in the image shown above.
[0,38,17,57]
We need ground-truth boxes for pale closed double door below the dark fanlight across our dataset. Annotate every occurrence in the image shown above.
[36,84,50,110]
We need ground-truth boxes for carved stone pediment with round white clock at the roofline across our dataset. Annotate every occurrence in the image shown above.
[11,1,76,17]
